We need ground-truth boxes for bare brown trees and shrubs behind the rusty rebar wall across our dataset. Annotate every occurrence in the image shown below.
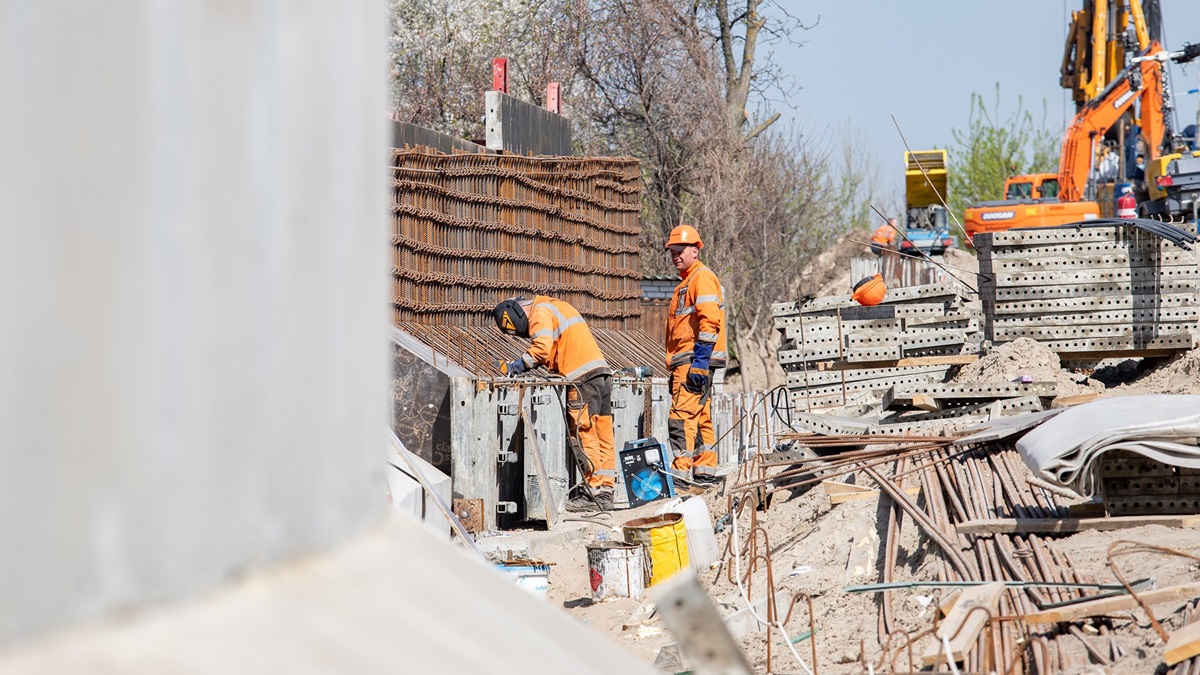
[392,0,864,389]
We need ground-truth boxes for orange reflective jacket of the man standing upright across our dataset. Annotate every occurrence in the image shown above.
[666,261,730,370]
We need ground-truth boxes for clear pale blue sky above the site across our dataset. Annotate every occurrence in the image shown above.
[772,0,1200,196]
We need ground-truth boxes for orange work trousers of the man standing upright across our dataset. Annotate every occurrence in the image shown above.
[667,363,716,476]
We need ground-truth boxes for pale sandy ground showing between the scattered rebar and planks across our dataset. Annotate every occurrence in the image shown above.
[494,237,1200,674]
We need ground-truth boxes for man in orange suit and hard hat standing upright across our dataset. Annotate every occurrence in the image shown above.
[666,225,728,484]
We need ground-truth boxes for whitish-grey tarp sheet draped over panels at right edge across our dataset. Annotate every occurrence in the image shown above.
[1016,394,1200,496]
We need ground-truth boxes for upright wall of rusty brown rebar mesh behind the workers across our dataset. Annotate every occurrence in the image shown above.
[391,149,642,330]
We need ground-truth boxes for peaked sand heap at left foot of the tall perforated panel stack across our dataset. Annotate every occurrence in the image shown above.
[953,338,1099,396]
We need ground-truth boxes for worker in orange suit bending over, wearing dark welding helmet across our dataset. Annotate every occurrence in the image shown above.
[492,295,617,510]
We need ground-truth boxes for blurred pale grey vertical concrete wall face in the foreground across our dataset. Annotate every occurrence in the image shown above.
[0,0,390,640]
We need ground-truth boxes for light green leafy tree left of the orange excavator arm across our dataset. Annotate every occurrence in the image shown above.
[948,83,1061,216]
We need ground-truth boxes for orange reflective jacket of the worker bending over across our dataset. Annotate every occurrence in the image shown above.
[521,295,611,381]
